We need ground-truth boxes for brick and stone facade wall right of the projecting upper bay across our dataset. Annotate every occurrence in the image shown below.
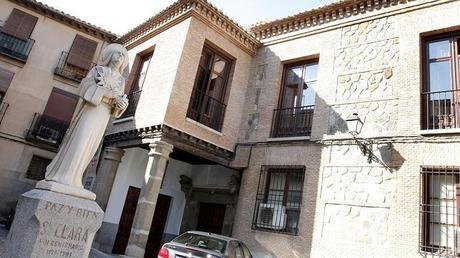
[236,0,460,258]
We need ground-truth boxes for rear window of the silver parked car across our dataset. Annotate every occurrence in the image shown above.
[173,233,227,254]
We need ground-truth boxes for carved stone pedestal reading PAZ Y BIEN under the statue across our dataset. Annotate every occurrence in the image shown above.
[3,189,104,258]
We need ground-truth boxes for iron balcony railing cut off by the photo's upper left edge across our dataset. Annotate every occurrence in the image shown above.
[0,28,35,62]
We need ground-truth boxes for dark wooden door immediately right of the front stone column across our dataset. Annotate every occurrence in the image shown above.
[144,194,171,258]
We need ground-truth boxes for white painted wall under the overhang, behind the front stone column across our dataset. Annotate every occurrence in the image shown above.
[104,145,238,235]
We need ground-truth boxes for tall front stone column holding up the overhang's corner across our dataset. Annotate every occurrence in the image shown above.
[125,139,174,258]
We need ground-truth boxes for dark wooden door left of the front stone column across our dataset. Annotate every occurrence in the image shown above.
[112,186,141,254]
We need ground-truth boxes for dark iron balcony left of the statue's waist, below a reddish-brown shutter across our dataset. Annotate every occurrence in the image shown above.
[26,113,69,146]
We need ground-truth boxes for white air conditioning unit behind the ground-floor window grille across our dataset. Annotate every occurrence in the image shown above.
[257,203,287,230]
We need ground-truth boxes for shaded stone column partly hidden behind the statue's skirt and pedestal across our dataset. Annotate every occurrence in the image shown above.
[93,147,125,211]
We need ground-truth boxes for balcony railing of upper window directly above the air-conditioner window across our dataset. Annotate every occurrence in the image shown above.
[270,105,315,138]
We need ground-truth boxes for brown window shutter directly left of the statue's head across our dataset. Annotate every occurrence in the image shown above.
[67,35,97,70]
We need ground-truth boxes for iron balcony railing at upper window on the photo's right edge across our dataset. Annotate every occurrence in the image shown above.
[422,90,460,130]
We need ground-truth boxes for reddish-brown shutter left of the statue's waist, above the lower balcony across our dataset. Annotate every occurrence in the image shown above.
[43,88,78,122]
